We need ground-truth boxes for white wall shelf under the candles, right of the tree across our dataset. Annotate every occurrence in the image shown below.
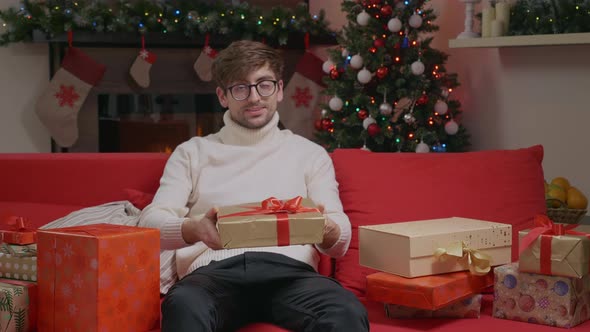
[449,32,590,48]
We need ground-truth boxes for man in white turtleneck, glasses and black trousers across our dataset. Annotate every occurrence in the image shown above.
[140,41,369,332]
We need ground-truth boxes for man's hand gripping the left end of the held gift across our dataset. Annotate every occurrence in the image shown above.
[181,207,222,250]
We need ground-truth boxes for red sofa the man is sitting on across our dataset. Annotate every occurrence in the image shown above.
[0,146,590,332]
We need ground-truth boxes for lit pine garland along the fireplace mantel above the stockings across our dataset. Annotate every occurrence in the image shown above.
[0,0,335,46]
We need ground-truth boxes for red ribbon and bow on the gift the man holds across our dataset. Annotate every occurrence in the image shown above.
[218,196,319,246]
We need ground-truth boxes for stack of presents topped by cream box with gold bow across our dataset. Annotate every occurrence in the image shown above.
[359,217,512,318]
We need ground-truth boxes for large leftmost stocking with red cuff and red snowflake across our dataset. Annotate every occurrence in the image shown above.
[35,47,106,147]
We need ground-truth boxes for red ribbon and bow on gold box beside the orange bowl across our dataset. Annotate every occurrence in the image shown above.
[518,214,590,274]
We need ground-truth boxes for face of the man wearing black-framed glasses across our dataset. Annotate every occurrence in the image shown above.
[216,65,283,129]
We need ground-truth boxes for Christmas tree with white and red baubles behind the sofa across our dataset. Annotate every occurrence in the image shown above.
[315,0,469,152]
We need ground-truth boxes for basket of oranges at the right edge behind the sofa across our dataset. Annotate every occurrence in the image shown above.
[545,176,588,224]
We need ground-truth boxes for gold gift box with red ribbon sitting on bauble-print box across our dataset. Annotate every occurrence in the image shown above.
[519,215,590,278]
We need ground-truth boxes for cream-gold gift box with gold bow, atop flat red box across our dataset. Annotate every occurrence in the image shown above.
[359,217,512,278]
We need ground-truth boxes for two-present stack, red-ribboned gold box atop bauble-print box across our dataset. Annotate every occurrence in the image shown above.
[493,215,590,328]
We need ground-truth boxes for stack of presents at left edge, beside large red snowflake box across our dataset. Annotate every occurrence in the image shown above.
[0,216,38,332]
